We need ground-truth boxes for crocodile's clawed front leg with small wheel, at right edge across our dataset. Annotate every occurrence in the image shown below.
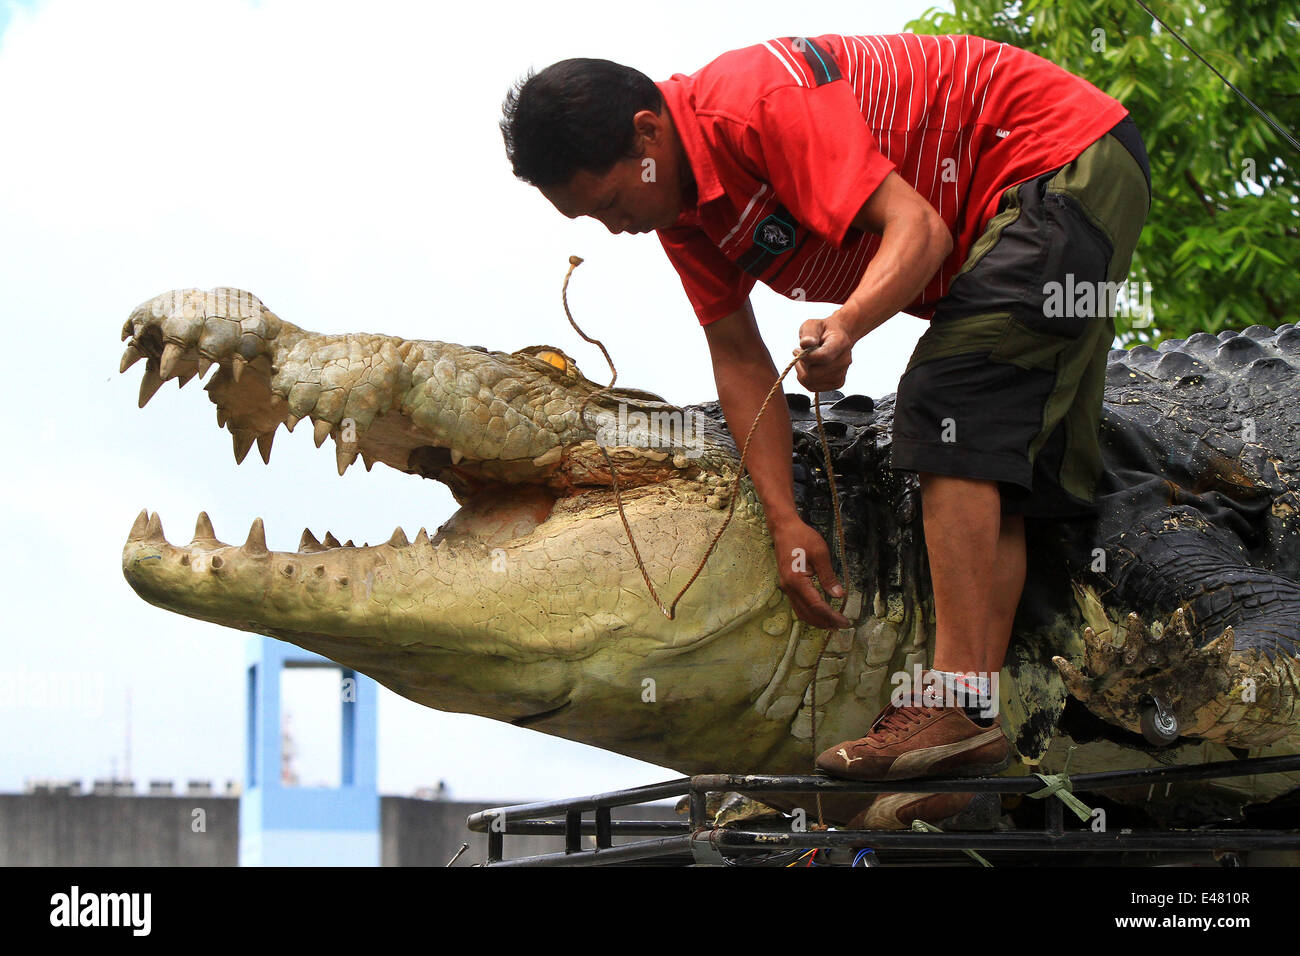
[1053,507,1300,748]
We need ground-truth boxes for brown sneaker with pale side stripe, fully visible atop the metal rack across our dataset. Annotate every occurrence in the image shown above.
[816,704,1011,780]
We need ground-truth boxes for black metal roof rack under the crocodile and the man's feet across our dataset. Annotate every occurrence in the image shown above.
[467,754,1300,866]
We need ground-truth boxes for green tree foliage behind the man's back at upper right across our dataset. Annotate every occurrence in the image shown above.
[907,0,1300,345]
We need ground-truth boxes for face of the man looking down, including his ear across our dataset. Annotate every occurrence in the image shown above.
[541,109,683,233]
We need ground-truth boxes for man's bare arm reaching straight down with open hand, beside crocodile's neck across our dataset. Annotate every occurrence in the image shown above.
[705,299,850,628]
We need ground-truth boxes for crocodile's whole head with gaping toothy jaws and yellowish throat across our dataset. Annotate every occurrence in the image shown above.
[122,289,897,771]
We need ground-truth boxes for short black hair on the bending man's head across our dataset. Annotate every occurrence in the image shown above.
[501,59,663,186]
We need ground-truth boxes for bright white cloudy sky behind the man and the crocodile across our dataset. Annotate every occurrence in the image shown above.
[0,0,932,803]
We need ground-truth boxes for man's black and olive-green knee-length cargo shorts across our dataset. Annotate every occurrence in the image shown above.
[891,117,1151,518]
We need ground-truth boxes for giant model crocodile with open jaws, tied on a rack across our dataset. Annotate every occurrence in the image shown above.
[121,289,1300,822]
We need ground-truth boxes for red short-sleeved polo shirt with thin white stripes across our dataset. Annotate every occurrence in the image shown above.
[657,34,1127,325]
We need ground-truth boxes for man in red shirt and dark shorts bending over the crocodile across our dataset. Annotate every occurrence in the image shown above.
[502,34,1151,826]
